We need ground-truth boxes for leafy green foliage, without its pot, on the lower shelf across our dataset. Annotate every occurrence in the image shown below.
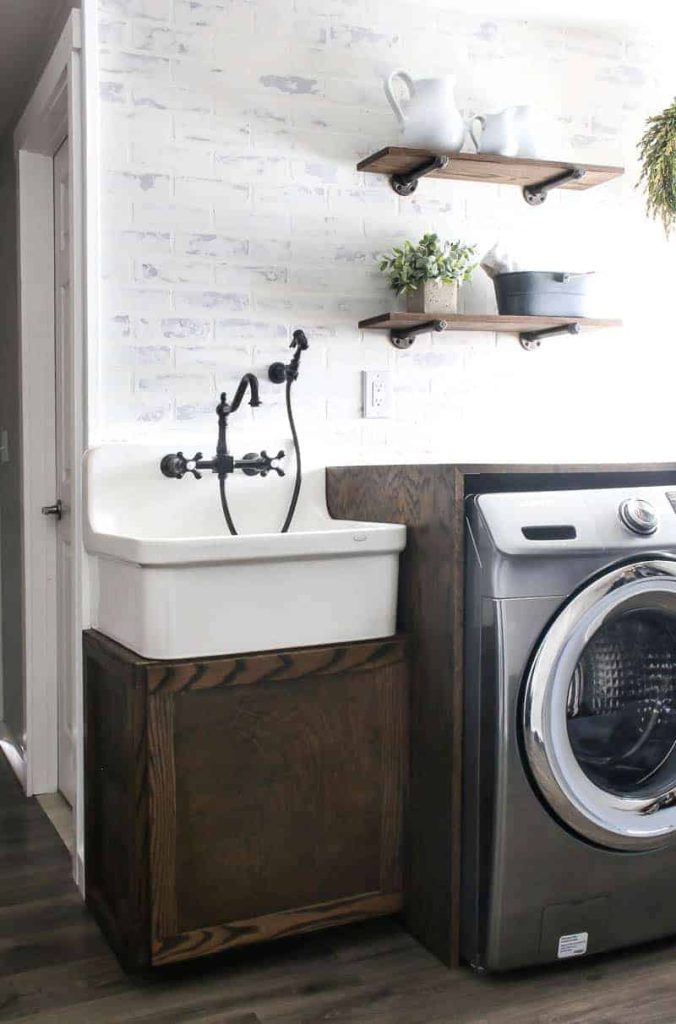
[379,234,478,295]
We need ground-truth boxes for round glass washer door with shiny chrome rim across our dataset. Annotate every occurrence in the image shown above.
[522,558,676,850]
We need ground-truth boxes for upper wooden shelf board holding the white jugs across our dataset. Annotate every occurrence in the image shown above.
[356,145,624,190]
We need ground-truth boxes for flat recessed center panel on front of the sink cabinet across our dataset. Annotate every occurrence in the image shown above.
[170,666,408,937]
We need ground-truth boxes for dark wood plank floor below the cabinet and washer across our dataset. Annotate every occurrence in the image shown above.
[0,756,676,1024]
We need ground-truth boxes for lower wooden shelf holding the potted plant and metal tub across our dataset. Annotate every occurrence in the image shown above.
[358,312,622,349]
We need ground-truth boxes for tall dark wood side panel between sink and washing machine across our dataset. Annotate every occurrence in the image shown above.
[327,466,463,963]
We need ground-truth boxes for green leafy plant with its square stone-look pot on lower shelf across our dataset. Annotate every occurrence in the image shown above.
[380,233,478,314]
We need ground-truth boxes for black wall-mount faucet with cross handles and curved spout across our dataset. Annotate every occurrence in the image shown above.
[160,374,285,480]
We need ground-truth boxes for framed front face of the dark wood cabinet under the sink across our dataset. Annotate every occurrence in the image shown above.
[149,641,408,963]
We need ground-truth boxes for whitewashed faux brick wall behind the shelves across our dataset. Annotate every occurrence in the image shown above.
[97,0,676,461]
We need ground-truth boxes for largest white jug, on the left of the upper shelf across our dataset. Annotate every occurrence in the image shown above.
[385,71,465,153]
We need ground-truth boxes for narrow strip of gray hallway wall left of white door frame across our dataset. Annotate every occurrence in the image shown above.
[0,136,25,740]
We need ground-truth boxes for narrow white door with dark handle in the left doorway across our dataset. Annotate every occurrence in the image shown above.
[54,139,76,806]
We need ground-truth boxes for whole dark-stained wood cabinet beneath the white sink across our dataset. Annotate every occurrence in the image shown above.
[84,631,409,967]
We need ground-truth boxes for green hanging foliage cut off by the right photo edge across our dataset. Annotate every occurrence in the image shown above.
[638,99,676,236]
